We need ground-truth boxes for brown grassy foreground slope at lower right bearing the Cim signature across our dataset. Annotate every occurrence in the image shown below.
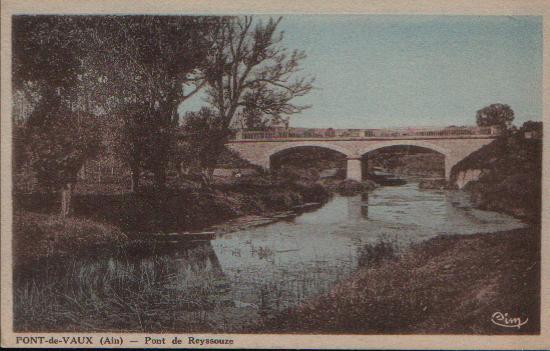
[264,227,540,334]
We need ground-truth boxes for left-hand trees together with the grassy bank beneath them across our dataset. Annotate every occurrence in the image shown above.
[13,15,328,261]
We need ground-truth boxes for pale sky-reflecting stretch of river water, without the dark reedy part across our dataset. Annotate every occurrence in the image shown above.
[208,184,522,316]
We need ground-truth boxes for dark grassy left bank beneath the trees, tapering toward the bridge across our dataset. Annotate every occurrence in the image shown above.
[13,177,329,265]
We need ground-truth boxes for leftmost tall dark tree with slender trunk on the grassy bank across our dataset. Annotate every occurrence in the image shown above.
[13,16,98,216]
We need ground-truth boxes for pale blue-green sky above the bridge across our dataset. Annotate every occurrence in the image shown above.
[182,15,543,128]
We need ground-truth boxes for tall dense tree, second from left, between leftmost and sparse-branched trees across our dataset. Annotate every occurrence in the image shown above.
[87,16,216,189]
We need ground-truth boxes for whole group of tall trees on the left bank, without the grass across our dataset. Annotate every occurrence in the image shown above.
[13,16,313,217]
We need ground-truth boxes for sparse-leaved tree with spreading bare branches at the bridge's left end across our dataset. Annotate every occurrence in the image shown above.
[202,16,313,176]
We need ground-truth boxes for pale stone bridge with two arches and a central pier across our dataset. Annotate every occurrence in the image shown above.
[227,127,499,181]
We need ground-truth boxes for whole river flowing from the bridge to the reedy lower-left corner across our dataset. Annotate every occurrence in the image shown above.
[14,183,524,332]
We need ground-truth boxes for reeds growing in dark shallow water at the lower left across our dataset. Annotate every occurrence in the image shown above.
[14,246,240,332]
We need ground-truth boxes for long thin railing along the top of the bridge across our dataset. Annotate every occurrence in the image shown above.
[233,127,500,140]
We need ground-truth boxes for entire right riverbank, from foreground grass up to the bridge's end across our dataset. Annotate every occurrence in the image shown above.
[264,122,542,334]
